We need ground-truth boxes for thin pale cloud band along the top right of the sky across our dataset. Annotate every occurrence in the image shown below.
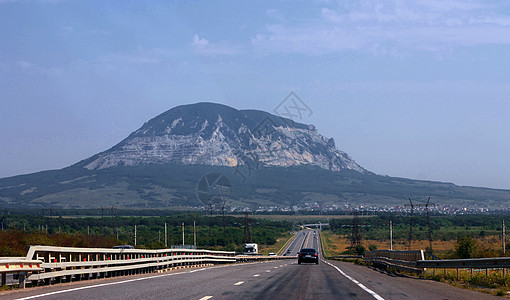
[251,0,510,55]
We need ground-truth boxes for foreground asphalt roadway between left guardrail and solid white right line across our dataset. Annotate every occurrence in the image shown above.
[0,260,373,299]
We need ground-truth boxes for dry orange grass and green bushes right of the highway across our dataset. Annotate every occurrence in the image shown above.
[321,215,510,296]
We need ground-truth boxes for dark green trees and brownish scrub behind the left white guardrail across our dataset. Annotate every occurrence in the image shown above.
[0,214,292,256]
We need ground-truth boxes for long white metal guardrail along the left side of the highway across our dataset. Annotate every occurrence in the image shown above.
[0,246,236,287]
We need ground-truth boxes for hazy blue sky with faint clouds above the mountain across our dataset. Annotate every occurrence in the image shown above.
[0,0,510,189]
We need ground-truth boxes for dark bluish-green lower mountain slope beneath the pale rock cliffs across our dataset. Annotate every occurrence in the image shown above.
[0,164,510,208]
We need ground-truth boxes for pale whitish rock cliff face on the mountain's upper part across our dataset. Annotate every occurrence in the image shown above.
[84,103,367,173]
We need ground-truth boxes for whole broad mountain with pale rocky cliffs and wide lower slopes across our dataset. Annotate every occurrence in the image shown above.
[0,103,510,209]
